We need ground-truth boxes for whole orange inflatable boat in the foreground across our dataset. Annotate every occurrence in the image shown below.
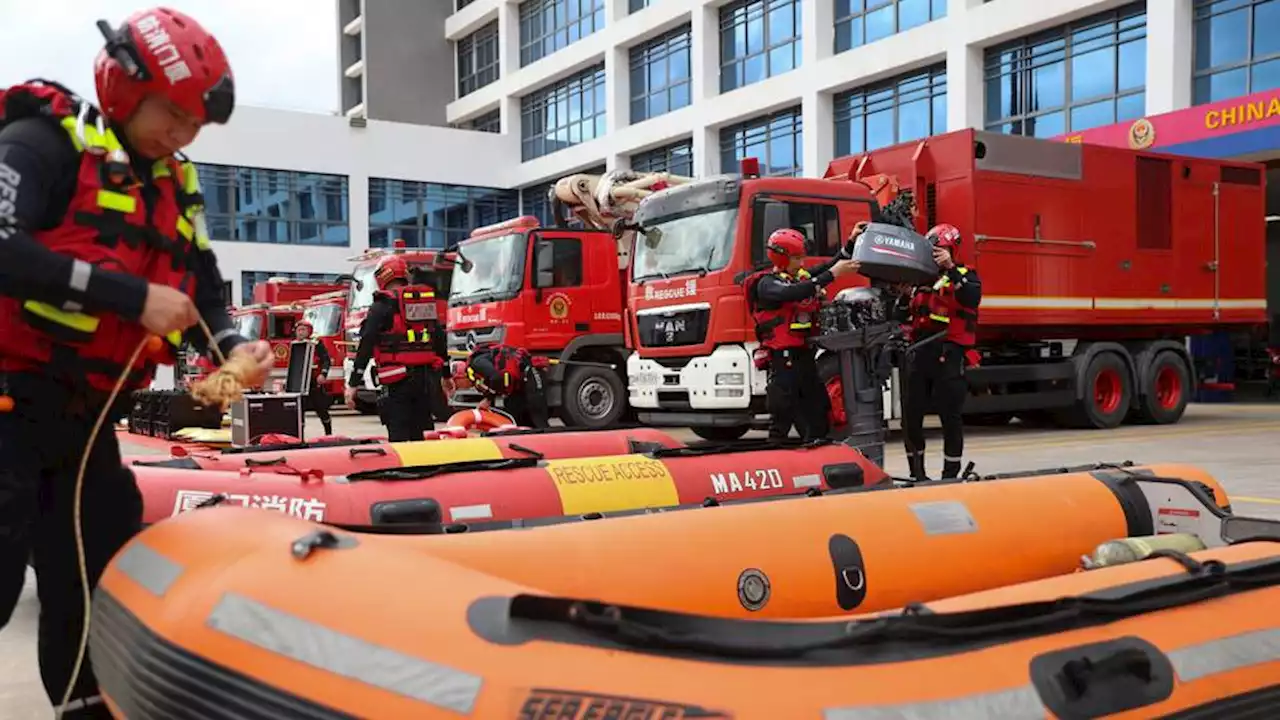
[91,468,1280,720]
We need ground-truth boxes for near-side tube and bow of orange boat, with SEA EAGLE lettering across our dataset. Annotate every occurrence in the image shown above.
[91,491,1280,720]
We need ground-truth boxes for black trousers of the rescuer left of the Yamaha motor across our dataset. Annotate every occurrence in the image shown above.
[765,347,831,439]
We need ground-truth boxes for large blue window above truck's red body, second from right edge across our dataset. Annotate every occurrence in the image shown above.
[984,3,1147,137]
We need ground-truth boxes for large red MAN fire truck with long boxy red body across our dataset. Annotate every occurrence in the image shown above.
[627,129,1267,438]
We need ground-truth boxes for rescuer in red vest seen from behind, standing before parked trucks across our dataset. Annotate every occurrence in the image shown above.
[346,255,449,442]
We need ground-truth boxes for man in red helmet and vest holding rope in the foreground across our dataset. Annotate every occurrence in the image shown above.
[0,8,271,717]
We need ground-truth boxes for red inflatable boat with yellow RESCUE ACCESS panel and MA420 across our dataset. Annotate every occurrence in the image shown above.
[133,433,886,525]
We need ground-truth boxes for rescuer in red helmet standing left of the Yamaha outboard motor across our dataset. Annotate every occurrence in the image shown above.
[744,228,858,439]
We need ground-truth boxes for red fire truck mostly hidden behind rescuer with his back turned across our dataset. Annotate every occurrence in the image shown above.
[334,240,453,415]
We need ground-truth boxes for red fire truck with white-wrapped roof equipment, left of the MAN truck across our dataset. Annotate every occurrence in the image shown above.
[449,170,689,428]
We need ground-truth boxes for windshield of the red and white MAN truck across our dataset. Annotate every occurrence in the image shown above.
[631,208,737,281]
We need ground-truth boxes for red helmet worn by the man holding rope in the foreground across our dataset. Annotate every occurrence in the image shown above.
[93,8,236,123]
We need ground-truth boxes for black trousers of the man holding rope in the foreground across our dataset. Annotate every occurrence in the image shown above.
[0,374,142,719]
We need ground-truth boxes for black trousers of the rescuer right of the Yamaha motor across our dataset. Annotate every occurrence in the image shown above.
[902,341,969,480]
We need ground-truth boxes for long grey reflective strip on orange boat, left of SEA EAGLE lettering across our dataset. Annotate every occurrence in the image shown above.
[205,589,484,715]
